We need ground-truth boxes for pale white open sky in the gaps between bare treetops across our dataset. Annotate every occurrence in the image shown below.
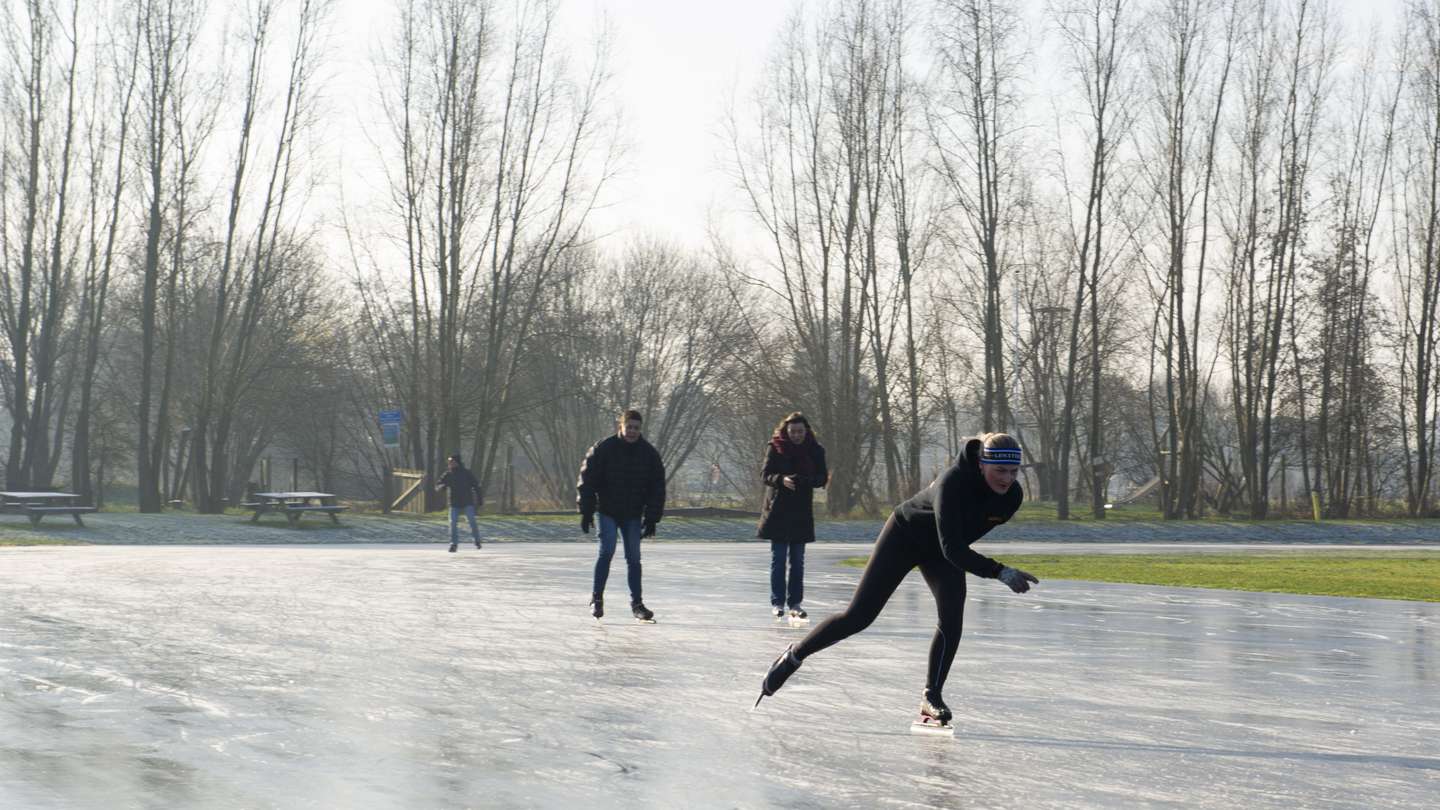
[323,0,1401,257]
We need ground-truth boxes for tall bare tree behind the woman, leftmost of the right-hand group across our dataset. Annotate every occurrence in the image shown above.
[732,0,903,515]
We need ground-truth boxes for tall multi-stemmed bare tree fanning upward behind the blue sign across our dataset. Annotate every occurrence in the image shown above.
[369,0,615,498]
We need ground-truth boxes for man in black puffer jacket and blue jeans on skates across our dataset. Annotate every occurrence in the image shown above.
[575,411,665,621]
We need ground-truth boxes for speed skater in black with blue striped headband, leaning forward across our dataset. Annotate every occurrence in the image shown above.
[756,434,1040,728]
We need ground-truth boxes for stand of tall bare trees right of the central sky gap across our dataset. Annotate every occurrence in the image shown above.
[732,0,1440,517]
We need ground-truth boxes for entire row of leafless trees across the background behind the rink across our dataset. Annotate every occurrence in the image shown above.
[0,0,1440,517]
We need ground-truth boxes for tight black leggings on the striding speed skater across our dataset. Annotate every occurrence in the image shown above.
[795,515,965,692]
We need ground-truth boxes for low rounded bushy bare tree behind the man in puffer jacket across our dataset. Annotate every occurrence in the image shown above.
[513,239,746,504]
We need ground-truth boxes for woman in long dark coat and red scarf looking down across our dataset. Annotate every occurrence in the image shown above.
[755,411,829,618]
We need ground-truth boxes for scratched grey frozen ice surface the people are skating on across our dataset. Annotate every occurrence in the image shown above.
[0,543,1440,809]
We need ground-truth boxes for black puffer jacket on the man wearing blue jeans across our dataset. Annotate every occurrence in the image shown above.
[575,435,665,523]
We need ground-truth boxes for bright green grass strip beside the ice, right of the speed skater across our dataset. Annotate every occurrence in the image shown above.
[844,552,1440,602]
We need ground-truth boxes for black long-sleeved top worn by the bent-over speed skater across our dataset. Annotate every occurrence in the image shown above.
[896,438,1025,579]
